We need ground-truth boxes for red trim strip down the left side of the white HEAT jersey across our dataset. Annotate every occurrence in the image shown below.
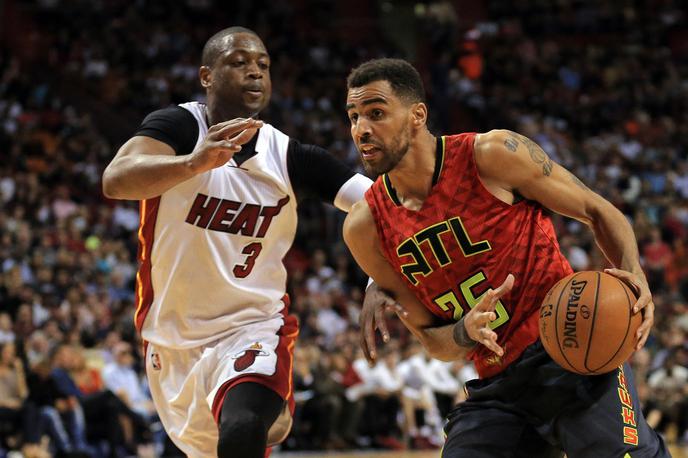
[134,197,160,333]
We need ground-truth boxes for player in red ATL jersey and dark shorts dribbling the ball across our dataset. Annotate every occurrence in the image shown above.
[344,59,669,458]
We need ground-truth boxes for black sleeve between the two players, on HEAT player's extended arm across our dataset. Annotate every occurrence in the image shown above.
[287,138,355,203]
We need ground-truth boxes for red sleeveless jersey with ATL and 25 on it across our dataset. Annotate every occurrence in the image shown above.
[365,133,572,378]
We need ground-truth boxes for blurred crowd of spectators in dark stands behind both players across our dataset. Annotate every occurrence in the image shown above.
[0,0,688,456]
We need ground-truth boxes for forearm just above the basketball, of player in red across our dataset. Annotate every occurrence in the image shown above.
[591,202,644,277]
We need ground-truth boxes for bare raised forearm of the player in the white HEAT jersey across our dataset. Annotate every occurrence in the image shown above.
[103,154,196,200]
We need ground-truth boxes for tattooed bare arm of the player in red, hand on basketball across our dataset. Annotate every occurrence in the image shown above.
[475,130,654,350]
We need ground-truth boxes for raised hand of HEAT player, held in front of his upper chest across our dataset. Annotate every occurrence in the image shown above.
[189,118,263,174]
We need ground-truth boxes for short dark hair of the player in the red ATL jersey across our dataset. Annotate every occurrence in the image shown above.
[346,58,425,103]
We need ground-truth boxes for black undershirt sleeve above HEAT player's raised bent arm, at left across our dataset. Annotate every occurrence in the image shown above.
[134,106,198,155]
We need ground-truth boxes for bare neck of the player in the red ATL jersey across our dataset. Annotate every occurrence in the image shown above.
[389,130,437,209]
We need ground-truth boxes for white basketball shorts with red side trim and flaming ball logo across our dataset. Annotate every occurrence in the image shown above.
[146,315,298,458]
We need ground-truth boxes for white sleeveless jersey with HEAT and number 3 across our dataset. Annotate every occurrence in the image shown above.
[135,102,297,348]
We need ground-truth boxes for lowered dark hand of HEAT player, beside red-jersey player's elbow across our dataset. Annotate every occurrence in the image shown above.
[358,283,407,364]
